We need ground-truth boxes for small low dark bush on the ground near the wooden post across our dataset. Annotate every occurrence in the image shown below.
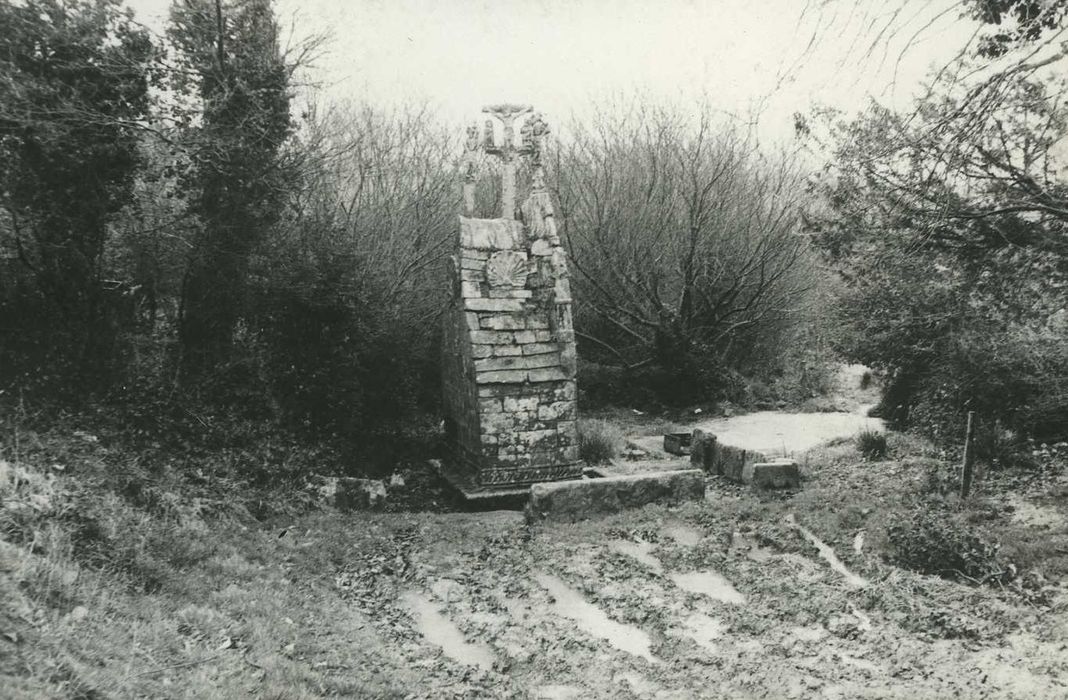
[886,507,1002,582]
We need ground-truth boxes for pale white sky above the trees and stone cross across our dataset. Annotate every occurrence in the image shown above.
[128,0,976,140]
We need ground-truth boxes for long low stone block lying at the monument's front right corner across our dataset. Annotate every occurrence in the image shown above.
[527,469,705,523]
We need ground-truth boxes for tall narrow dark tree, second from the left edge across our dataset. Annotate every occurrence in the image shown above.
[169,0,294,378]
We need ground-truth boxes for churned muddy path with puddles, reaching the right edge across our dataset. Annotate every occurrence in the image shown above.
[324,493,1068,698]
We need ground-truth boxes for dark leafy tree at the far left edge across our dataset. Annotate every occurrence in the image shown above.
[0,0,155,386]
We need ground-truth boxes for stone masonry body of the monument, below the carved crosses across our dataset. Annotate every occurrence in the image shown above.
[442,217,581,491]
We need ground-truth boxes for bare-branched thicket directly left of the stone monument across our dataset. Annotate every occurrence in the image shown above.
[255,99,459,430]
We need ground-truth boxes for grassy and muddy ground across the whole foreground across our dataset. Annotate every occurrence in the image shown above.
[0,380,1068,700]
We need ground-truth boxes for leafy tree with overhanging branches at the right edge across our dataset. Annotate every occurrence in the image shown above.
[813,20,1068,444]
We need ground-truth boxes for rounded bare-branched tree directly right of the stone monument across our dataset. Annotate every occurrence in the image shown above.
[555,99,811,378]
